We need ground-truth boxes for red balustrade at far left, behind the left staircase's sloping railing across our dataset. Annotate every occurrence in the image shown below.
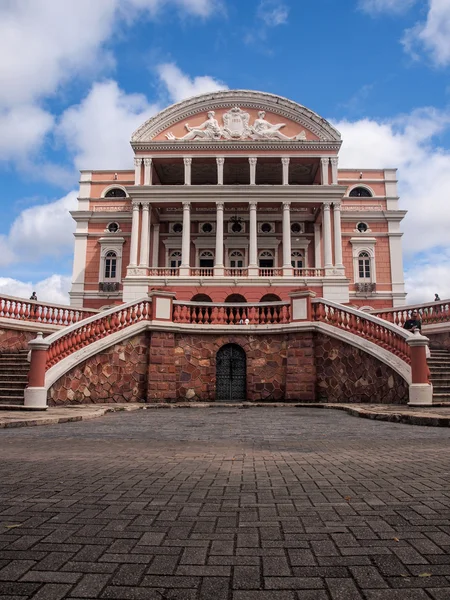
[0,296,99,325]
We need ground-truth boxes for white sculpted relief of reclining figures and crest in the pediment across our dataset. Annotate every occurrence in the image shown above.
[166,106,306,142]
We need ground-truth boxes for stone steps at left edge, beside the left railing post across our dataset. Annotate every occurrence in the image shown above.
[0,350,30,409]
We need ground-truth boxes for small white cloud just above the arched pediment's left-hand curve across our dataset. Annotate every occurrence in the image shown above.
[156,63,228,102]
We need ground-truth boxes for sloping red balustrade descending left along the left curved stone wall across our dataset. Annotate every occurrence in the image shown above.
[45,300,152,370]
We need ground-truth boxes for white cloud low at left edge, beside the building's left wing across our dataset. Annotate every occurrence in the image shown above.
[0,192,77,267]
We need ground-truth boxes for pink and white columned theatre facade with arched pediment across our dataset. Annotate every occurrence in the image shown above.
[70,90,406,308]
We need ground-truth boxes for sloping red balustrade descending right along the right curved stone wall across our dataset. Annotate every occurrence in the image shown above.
[312,299,411,364]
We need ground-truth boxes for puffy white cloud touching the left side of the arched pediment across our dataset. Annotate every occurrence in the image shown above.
[56,81,158,169]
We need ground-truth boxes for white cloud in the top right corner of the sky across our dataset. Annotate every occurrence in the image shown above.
[403,0,450,67]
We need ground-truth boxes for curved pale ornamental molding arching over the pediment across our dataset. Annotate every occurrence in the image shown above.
[131,90,341,148]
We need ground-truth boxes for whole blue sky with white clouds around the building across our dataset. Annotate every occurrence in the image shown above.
[0,0,450,302]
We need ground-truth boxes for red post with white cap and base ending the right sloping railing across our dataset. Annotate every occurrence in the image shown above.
[406,332,433,406]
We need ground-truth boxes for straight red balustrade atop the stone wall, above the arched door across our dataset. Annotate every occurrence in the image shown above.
[173,301,291,325]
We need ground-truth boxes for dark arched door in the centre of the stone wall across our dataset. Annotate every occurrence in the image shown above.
[216,344,247,402]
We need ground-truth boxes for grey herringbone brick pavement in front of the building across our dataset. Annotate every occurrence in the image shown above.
[0,407,450,600]
